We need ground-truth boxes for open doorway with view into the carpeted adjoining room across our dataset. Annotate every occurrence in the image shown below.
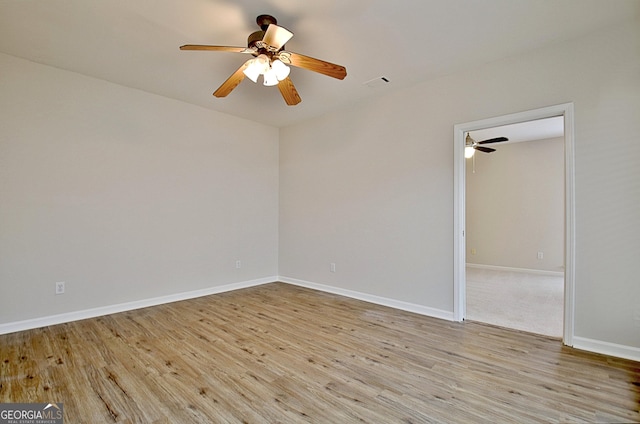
[465,116,564,338]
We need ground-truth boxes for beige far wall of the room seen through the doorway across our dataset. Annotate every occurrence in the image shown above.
[465,138,565,272]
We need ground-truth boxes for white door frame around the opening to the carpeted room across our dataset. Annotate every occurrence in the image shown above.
[453,103,575,346]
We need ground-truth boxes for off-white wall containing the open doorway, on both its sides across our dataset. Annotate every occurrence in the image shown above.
[280,17,640,357]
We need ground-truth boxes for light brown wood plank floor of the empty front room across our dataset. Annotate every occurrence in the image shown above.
[0,283,640,423]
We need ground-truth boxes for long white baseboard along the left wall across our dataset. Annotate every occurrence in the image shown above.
[0,277,278,334]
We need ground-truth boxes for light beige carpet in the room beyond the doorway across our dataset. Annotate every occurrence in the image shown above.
[466,267,564,338]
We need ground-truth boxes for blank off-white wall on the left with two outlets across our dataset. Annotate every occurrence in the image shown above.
[0,54,279,324]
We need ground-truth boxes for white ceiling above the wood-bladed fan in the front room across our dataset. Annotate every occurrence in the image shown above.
[0,0,640,127]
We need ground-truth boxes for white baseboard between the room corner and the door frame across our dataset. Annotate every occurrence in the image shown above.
[279,276,453,321]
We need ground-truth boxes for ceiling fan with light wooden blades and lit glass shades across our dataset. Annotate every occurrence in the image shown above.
[180,15,347,106]
